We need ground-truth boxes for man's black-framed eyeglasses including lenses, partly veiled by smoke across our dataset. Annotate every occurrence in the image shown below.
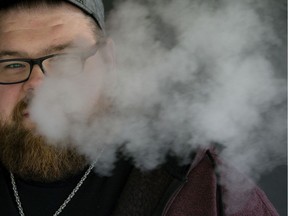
[0,45,100,85]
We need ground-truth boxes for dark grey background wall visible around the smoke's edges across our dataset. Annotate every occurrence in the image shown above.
[103,0,287,216]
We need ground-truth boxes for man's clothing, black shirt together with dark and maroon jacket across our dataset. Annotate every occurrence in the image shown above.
[0,149,279,216]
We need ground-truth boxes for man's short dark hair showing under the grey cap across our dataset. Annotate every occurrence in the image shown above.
[0,0,104,41]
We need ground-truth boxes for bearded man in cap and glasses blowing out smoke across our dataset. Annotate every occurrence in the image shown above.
[0,0,278,216]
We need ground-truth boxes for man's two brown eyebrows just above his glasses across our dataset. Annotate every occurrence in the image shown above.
[0,41,73,58]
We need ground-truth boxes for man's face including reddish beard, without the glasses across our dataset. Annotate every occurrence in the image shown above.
[0,4,97,181]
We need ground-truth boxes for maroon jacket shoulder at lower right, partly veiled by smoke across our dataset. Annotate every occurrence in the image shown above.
[165,149,279,216]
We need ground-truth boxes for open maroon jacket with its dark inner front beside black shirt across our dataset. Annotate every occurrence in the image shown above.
[113,150,278,216]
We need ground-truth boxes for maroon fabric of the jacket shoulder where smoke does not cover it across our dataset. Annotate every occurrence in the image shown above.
[163,150,278,216]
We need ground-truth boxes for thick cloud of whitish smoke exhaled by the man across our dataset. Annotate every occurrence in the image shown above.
[31,0,286,182]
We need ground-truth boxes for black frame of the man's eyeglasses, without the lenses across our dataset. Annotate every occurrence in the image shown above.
[0,43,101,85]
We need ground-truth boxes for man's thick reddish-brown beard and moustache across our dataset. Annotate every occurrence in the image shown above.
[0,100,87,182]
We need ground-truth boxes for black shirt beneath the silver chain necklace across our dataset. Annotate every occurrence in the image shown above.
[0,161,132,216]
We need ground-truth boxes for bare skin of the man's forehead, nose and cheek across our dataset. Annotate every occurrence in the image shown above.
[0,4,97,125]
